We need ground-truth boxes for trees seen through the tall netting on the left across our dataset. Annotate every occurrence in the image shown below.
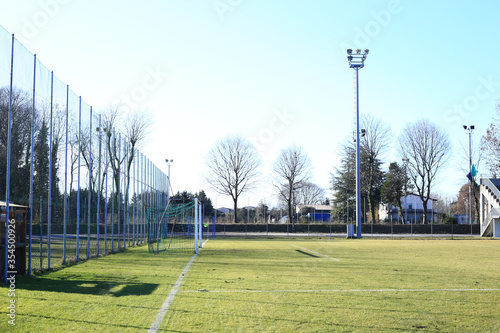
[0,83,151,223]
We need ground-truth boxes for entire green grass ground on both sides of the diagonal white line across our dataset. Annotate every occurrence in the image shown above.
[0,239,500,332]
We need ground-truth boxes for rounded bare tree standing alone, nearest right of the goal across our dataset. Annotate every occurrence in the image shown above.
[207,135,260,223]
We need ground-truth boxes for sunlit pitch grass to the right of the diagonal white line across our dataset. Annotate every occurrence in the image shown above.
[162,239,500,332]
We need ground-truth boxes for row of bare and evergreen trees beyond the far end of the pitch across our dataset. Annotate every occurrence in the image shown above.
[203,103,500,223]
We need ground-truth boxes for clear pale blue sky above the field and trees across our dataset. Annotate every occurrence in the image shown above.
[0,0,500,206]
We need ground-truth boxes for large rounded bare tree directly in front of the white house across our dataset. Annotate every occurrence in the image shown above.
[399,120,451,223]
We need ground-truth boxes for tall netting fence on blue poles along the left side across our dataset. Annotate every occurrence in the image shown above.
[0,27,168,281]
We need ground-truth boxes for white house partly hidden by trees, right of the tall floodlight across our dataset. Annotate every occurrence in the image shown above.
[379,194,437,223]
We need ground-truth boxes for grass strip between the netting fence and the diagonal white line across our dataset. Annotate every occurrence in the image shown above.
[0,245,193,332]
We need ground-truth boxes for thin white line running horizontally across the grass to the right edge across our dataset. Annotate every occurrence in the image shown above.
[180,288,500,293]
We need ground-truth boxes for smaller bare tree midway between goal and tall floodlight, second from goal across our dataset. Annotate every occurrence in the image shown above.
[273,145,311,225]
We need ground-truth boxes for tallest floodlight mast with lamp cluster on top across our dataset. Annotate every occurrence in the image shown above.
[347,49,369,238]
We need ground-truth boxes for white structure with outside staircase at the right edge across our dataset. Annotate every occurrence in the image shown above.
[479,178,500,238]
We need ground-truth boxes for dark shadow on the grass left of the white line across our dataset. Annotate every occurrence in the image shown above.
[16,277,158,297]
